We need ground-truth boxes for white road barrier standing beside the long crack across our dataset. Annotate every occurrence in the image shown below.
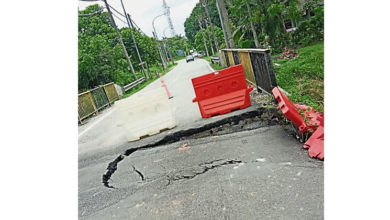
[115,87,176,141]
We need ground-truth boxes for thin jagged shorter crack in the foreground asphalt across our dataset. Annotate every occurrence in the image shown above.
[166,159,242,186]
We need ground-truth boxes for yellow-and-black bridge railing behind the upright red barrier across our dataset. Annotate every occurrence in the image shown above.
[221,49,277,94]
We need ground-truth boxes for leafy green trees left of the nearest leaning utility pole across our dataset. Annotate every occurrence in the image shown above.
[78,5,131,91]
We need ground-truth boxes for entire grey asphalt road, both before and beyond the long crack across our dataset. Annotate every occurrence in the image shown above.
[78,57,324,220]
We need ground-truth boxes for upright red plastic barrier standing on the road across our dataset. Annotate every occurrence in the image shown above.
[192,64,253,118]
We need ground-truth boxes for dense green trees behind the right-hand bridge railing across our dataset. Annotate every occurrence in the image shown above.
[184,0,324,52]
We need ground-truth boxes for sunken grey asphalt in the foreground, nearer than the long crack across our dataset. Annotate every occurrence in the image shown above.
[79,125,324,219]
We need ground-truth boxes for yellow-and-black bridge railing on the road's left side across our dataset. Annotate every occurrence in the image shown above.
[78,82,119,123]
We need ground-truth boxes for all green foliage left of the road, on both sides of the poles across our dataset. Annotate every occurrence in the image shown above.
[78,4,159,92]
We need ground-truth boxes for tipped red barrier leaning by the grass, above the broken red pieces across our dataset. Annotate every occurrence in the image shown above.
[272,87,308,132]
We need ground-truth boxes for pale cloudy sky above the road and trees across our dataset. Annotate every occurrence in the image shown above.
[78,0,199,38]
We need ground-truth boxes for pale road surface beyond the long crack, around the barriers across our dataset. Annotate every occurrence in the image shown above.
[79,59,213,154]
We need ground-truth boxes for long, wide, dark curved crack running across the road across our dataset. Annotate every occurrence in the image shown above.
[102,108,278,188]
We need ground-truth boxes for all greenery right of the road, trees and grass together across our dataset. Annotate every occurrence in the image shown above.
[184,0,324,111]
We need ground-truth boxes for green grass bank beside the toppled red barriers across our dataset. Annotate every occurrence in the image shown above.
[273,42,324,111]
